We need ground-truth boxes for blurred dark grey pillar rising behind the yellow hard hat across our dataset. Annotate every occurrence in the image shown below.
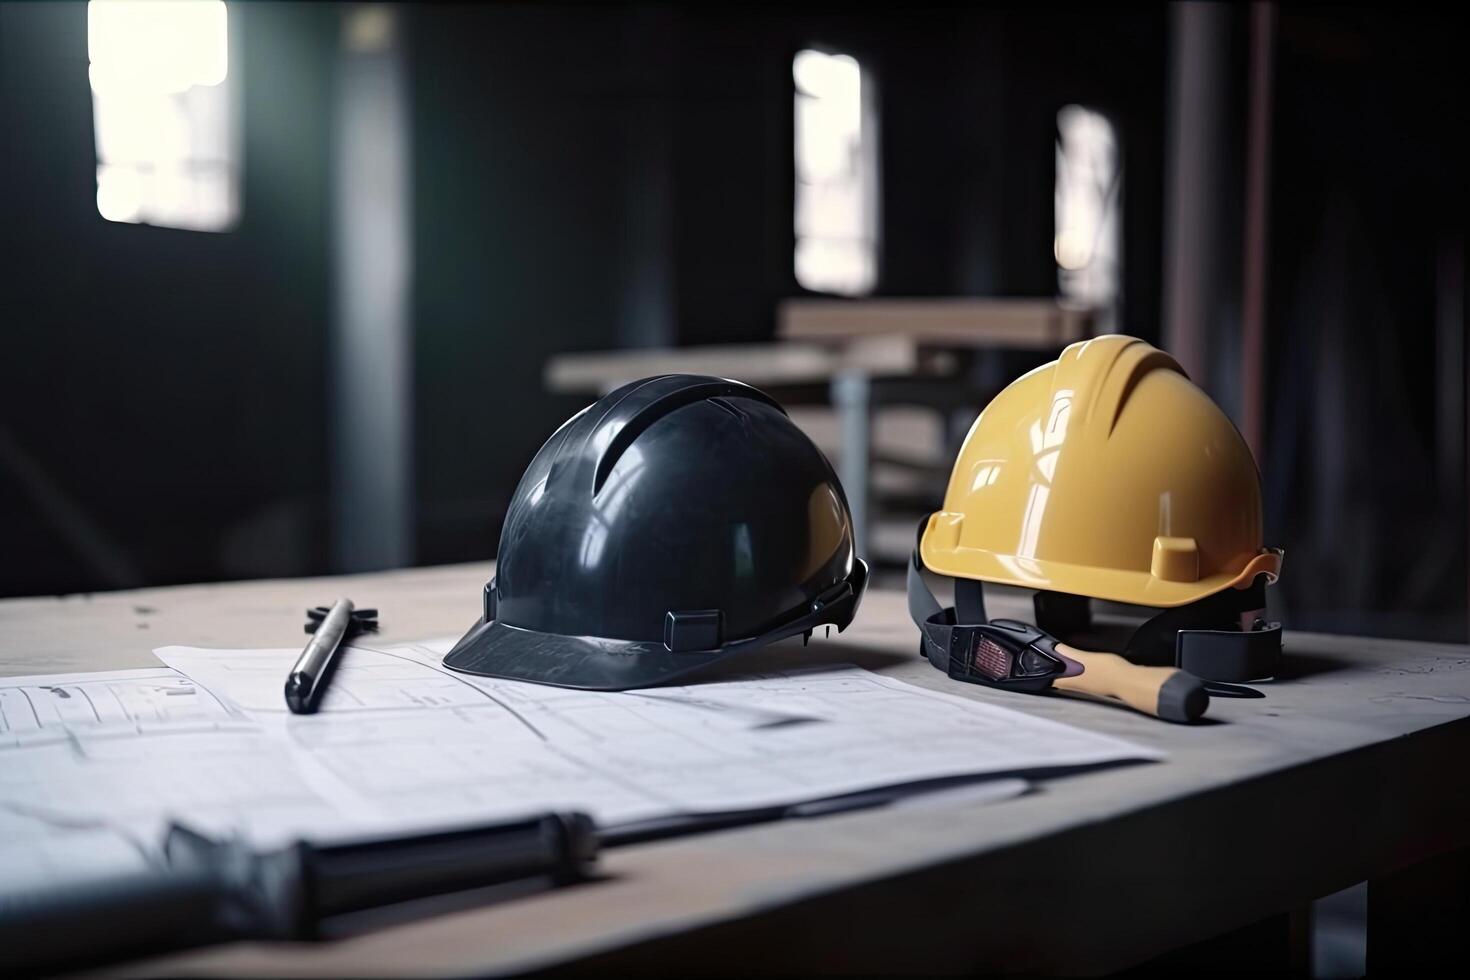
[1163,3,1230,387]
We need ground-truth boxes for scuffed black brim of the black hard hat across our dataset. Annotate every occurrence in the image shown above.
[444,620,739,691]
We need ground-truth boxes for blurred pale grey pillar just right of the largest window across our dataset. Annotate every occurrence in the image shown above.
[328,4,415,572]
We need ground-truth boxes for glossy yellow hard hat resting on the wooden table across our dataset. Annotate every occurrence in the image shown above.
[916,335,1282,674]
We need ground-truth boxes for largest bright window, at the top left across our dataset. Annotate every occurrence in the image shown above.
[87,0,240,231]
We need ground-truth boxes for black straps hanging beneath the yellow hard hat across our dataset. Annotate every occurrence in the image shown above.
[907,522,1282,682]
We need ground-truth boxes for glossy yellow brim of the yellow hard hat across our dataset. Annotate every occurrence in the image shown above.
[919,535,1280,608]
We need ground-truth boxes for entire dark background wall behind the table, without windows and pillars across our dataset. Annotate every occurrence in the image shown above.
[0,3,1466,639]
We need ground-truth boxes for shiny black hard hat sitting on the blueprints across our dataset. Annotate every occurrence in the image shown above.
[444,375,867,691]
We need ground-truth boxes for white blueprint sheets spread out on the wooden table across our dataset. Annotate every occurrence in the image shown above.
[0,641,1160,887]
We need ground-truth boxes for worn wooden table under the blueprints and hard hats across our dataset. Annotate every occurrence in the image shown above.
[0,564,1470,976]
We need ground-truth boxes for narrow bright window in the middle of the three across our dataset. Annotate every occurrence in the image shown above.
[792,50,878,295]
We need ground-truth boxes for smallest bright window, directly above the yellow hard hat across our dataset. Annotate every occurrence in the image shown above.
[1053,106,1123,331]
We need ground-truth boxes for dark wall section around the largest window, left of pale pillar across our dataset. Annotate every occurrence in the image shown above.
[0,3,337,594]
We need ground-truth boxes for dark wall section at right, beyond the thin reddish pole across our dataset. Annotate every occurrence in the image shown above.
[1263,7,1467,639]
